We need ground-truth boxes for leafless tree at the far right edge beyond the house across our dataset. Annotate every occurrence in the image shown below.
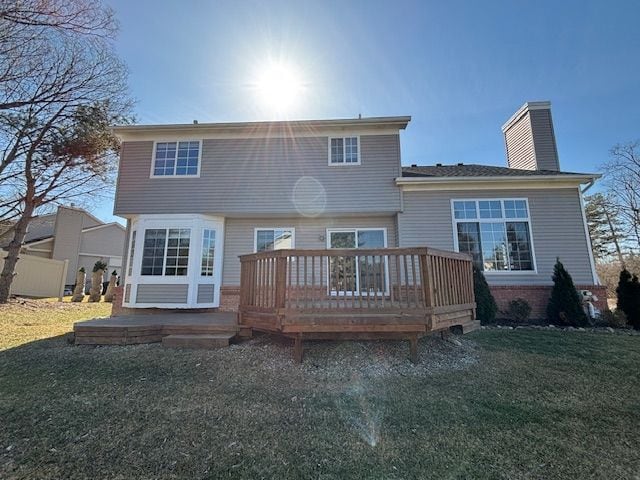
[604,141,640,251]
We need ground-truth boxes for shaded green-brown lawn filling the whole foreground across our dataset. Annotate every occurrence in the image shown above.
[0,302,640,479]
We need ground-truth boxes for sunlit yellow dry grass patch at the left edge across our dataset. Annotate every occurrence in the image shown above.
[0,297,111,350]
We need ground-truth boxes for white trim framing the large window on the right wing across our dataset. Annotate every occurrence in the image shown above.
[451,197,538,276]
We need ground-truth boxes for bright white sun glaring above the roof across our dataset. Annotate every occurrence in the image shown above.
[255,63,304,113]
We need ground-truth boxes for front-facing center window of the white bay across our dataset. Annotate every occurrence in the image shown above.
[140,228,191,276]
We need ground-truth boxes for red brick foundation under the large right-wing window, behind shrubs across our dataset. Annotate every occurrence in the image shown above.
[489,285,608,319]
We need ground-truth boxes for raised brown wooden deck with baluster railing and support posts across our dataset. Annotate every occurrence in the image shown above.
[239,248,477,361]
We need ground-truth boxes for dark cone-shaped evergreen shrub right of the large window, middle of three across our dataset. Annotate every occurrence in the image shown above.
[547,259,588,327]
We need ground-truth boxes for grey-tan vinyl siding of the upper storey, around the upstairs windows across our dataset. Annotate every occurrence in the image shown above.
[115,135,400,216]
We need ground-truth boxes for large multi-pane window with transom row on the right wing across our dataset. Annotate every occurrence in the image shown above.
[452,199,535,272]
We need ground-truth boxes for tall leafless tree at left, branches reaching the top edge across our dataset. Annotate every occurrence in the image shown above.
[0,0,131,303]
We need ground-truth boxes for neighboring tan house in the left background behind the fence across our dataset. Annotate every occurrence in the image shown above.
[22,207,125,286]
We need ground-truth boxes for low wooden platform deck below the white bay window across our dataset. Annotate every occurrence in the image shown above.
[73,312,238,345]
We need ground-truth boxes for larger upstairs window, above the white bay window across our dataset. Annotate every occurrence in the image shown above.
[152,140,200,177]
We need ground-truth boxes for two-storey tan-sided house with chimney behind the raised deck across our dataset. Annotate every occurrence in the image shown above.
[114,102,601,315]
